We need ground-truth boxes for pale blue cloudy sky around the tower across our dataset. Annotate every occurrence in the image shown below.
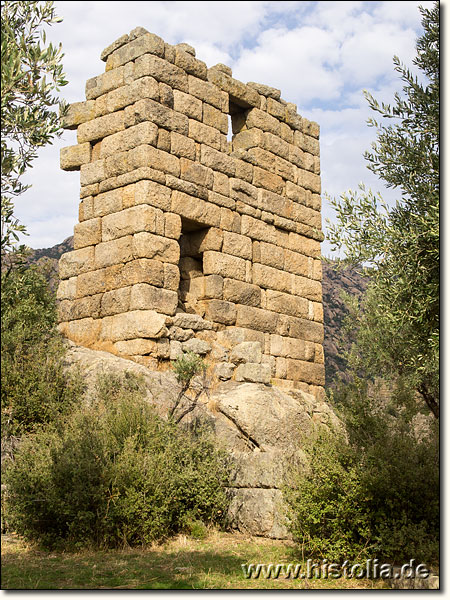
[15,0,440,255]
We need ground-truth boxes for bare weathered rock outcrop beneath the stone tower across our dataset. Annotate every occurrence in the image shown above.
[63,342,338,539]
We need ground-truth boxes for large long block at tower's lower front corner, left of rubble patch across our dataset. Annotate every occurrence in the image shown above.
[100,310,167,342]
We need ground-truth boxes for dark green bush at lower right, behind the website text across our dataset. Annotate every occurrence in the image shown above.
[286,382,439,563]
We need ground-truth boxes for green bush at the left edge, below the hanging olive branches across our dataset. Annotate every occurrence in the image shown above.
[1,266,82,441]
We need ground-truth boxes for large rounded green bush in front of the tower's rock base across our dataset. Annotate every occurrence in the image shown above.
[6,376,232,547]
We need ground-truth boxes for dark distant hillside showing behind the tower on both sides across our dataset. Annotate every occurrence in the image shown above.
[29,237,367,386]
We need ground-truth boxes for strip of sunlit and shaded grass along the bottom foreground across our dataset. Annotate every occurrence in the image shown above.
[2,532,385,590]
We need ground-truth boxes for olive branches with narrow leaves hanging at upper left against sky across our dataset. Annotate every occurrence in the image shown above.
[1,1,67,259]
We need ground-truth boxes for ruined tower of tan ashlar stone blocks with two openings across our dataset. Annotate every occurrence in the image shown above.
[58,27,324,394]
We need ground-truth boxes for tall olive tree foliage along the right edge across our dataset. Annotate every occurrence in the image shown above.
[328,2,439,417]
